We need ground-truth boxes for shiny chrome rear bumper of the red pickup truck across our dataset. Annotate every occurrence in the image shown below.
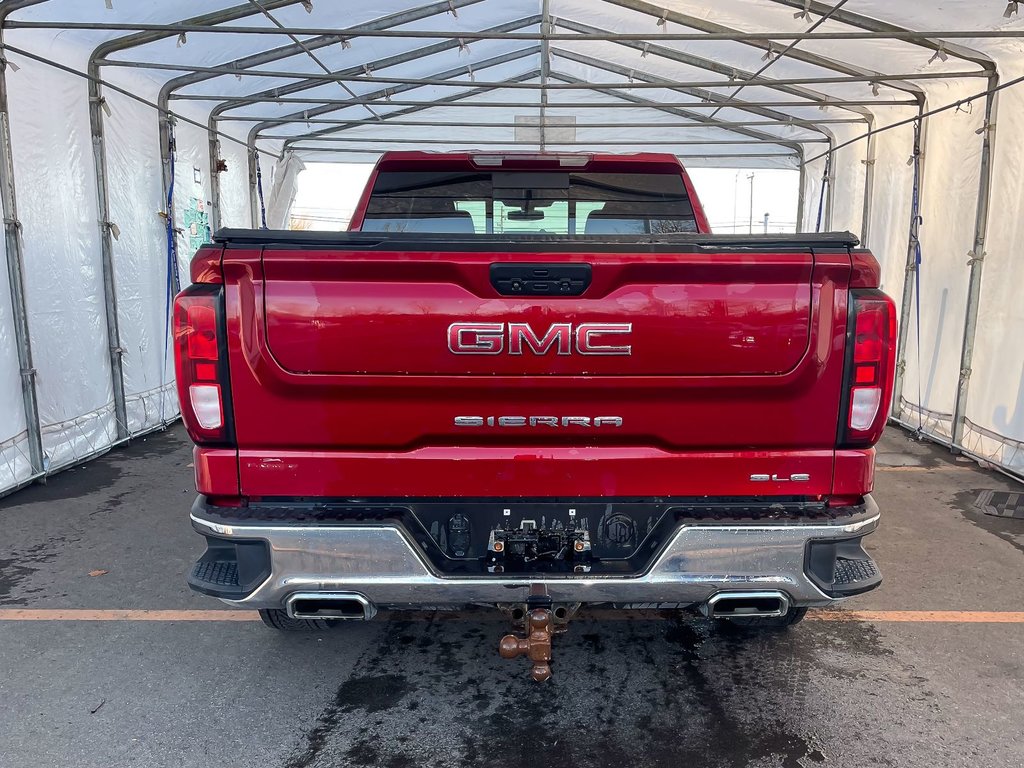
[191,497,879,608]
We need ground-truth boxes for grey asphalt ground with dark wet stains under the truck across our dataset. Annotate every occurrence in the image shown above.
[0,427,1024,768]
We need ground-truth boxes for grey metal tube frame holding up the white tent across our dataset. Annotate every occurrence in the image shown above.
[0,0,1024,493]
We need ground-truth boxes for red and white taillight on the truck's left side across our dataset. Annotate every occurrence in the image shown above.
[174,285,231,445]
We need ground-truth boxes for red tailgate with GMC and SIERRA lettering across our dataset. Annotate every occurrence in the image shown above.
[224,237,851,496]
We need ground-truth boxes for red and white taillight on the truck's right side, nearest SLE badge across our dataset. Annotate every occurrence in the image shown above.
[840,290,896,447]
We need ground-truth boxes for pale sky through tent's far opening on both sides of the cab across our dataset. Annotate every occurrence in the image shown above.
[292,163,800,234]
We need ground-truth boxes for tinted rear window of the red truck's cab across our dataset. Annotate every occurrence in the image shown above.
[360,171,697,236]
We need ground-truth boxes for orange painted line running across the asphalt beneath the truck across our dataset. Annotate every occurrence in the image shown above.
[0,608,1024,624]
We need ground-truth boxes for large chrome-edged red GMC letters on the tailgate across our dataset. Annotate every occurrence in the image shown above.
[447,323,633,355]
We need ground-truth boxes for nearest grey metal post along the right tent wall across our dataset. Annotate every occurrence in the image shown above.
[950,75,999,453]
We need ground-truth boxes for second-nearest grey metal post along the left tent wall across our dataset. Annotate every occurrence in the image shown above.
[89,69,130,441]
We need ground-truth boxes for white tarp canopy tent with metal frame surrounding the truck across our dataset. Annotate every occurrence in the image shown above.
[0,0,1024,493]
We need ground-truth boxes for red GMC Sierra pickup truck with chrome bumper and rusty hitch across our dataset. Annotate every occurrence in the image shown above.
[174,153,896,679]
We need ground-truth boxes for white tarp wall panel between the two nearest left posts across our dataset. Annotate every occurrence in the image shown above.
[7,54,117,469]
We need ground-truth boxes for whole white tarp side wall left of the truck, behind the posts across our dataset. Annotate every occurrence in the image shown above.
[0,35,249,494]
